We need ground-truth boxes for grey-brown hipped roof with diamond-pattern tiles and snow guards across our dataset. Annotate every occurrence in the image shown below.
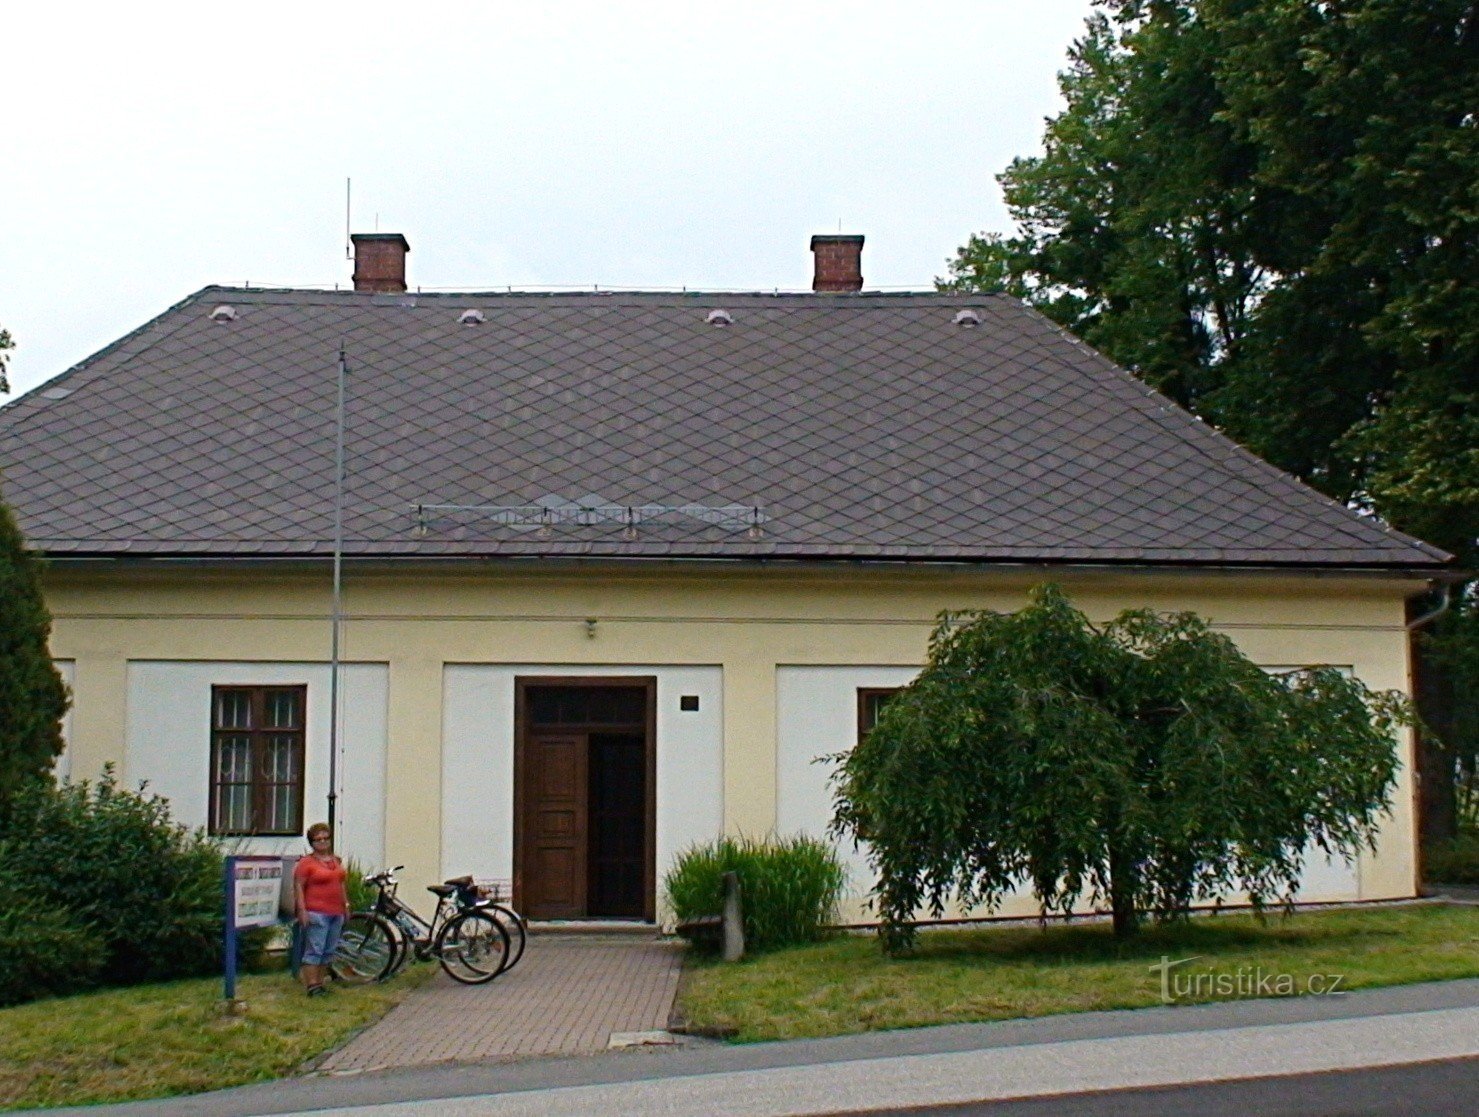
[0,287,1446,570]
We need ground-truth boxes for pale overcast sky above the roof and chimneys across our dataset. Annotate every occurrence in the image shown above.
[0,0,1090,399]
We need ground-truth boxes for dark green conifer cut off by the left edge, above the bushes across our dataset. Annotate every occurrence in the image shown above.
[0,491,68,808]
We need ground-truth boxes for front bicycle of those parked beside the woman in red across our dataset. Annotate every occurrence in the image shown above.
[330,865,512,985]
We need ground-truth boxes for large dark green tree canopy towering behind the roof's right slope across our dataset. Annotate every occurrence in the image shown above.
[947,0,1479,564]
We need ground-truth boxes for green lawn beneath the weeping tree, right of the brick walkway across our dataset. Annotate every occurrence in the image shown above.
[679,904,1479,1042]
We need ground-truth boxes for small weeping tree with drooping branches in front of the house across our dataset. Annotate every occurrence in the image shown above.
[833,586,1408,951]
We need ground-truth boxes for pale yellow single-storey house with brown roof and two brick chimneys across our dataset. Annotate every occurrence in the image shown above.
[0,234,1448,920]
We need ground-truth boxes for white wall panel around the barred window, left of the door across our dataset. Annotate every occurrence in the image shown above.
[123,660,389,870]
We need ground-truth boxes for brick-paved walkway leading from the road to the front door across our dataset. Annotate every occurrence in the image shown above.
[318,935,683,1074]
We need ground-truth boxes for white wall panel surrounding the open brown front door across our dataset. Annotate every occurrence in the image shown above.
[442,663,723,904]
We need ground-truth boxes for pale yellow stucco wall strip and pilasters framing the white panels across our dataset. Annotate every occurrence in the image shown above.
[47,564,1421,923]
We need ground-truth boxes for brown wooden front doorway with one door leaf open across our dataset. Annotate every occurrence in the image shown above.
[513,678,657,920]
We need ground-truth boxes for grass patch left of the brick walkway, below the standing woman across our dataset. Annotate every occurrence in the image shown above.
[0,966,435,1110]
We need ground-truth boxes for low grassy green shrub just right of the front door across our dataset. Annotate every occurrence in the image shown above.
[664,834,847,953]
